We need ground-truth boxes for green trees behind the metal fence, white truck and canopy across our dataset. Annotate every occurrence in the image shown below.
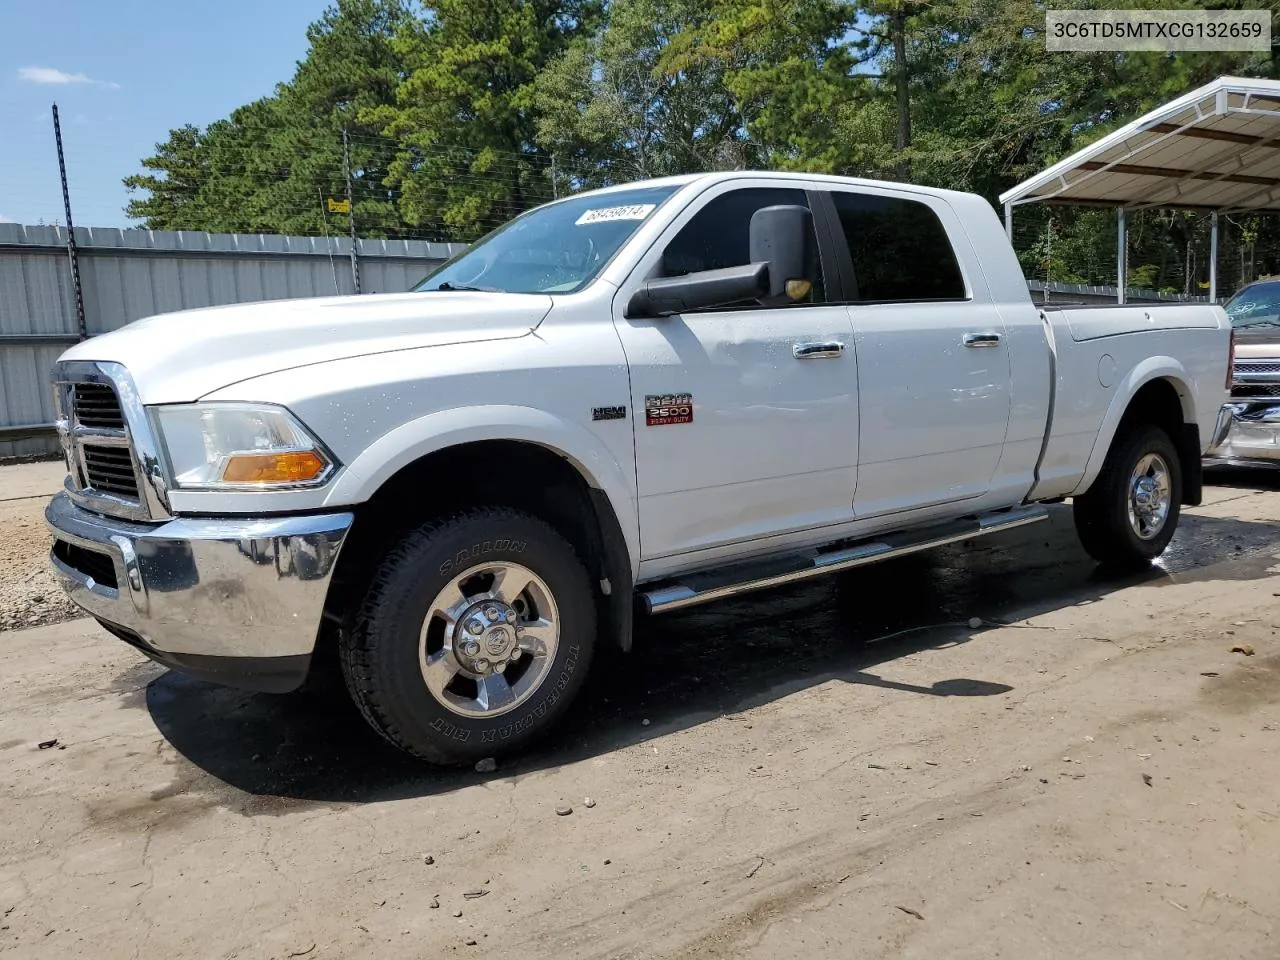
[125,0,1280,280]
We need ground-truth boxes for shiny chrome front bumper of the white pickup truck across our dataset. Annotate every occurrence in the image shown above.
[45,494,352,690]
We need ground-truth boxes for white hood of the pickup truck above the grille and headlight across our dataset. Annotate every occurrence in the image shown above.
[60,291,552,403]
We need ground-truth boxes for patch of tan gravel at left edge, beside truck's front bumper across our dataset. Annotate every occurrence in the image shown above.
[0,462,81,631]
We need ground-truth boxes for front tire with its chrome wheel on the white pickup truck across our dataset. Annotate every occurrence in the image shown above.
[339,507,596,764]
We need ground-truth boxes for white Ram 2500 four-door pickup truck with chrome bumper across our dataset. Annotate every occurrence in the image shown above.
[46,173,1231,763]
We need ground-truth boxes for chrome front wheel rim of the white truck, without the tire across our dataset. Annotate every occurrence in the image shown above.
[419,561,559,717]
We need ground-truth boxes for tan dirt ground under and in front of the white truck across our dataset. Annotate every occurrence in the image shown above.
[0,475,1280,960]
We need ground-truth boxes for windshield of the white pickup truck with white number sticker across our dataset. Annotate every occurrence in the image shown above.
[413,186,676,293]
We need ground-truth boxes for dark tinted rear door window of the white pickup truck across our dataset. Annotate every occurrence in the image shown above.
[831,192,965,302]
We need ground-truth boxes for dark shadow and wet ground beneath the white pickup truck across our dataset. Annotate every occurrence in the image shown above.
[145,507,1280,804]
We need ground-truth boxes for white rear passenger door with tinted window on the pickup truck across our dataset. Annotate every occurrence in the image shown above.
[829,188,1010,518]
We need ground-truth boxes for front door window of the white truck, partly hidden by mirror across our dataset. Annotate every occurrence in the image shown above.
[662,187,823,306]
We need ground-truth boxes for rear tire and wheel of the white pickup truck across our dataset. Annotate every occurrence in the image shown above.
[1073,424,1183,568]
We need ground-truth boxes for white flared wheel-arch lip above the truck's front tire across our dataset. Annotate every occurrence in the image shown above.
[325,404,640,573]
